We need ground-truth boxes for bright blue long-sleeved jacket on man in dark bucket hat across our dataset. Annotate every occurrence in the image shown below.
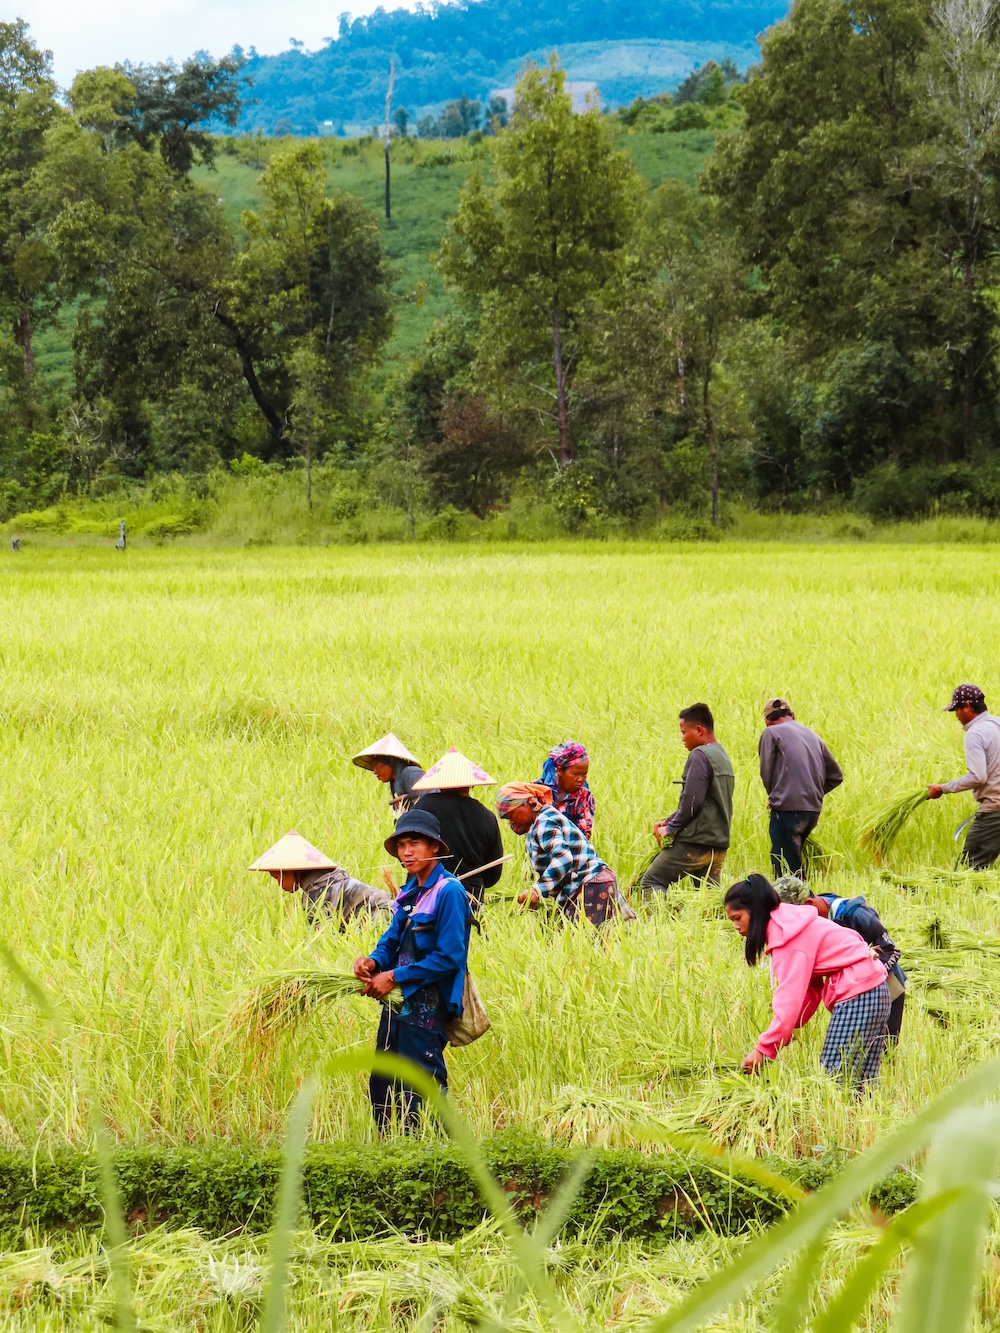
[371,865,472,1016]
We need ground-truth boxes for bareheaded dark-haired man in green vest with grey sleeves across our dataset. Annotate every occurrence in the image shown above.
[641,704,733,893]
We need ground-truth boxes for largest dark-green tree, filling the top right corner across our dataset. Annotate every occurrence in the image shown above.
[708,0,1000,479]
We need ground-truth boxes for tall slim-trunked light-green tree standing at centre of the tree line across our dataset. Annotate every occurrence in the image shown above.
[439,57,643,467]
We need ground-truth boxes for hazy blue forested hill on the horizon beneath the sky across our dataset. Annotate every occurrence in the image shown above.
[241,0,788,133]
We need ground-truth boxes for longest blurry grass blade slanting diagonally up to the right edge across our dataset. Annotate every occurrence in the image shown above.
[645,1058,1000,1333]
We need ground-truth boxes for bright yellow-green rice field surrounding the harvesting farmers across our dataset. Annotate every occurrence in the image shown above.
[0,544,1000,1329]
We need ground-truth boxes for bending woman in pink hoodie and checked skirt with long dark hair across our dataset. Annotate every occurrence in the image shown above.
[725,874,892,1086]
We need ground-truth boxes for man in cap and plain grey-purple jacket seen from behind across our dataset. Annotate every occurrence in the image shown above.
[757,698,844,874]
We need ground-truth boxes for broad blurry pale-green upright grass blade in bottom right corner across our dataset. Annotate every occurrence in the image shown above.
[899,1106,1000,1333]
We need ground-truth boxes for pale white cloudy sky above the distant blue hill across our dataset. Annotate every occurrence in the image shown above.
[9,0,416,87]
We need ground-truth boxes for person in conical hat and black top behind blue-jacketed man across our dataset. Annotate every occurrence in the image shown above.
[412,746,504,906]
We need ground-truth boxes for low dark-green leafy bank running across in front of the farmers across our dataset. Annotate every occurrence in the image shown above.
[0,1137,916,1238]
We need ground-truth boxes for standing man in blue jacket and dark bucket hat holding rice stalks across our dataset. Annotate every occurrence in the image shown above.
[355,810,472,1133]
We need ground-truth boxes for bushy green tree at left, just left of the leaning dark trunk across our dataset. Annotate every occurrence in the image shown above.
[39,116,245,472]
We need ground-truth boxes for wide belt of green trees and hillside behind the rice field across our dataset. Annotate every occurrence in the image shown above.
[0,0,1000,535]
